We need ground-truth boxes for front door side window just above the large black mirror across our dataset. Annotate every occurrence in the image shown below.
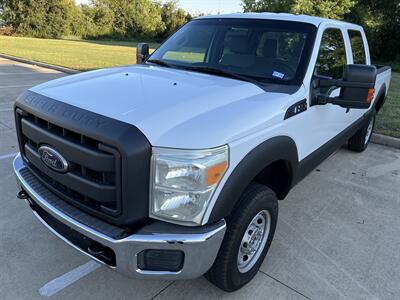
[316,28,347,79]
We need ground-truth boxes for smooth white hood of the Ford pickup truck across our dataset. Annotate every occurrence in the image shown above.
[31,65,291,149]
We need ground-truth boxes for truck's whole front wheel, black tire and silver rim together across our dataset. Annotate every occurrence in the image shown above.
[206,183,278,292]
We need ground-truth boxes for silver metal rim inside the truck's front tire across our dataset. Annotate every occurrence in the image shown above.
[237,210,271,273]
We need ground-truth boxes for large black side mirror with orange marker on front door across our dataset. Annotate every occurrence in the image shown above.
[312,65,376,109]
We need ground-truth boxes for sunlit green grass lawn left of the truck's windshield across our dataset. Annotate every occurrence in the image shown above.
[0,36,158,71]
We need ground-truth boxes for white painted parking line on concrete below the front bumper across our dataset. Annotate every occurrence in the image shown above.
[39,260,101,297]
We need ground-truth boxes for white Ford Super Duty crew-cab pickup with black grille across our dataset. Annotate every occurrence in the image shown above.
[14,13,391,291]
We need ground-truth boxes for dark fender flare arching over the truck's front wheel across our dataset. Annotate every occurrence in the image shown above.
[208,136,299,223]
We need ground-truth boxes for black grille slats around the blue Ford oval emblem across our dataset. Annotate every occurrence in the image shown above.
[18,114,121,215]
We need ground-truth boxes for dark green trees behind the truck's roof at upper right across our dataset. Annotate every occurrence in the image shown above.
[243,0,400,61]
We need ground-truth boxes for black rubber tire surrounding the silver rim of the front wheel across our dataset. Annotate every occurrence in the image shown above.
[205,183,278,292]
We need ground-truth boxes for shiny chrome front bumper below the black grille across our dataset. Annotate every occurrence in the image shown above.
[13,155,226,280]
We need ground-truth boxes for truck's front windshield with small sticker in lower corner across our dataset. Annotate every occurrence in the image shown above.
[148,18,317,84]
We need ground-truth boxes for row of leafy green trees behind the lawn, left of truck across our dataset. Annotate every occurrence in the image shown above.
[0,0,191,39]
